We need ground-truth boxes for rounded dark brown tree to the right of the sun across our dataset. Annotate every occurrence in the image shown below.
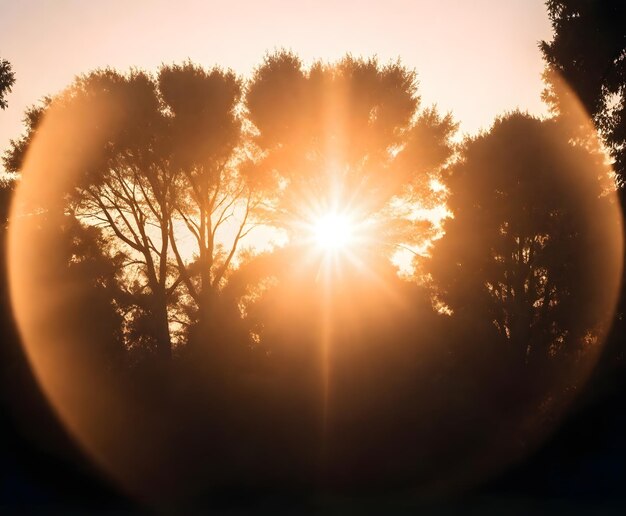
[430,113,619,378]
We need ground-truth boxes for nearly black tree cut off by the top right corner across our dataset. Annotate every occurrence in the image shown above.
[540,0,626,182]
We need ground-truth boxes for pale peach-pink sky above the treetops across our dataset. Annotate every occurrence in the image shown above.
[0,0,552,166]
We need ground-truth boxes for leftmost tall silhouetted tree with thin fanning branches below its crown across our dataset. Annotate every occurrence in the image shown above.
[5,70,180,356]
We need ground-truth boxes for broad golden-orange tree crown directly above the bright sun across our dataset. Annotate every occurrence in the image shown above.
[245,51,456,262]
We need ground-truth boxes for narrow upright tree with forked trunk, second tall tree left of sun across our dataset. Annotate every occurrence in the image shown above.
[158,63,258,337]
